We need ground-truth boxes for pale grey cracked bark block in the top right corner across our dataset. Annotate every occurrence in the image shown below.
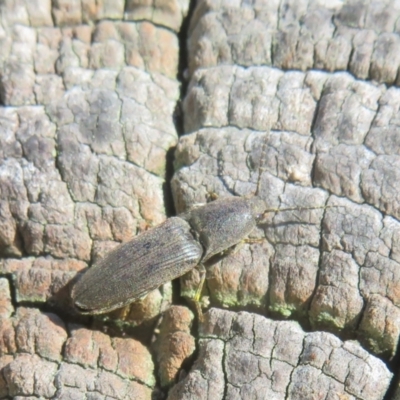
[189,0,400,85]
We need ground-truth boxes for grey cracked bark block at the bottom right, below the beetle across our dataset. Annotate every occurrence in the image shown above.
[168,309,390,400]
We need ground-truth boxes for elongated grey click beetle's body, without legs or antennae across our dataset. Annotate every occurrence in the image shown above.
[71,196,266,314]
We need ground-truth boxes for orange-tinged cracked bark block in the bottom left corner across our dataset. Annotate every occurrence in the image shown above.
[0,278,155,399]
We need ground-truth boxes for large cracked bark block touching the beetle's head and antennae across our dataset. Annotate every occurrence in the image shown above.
[173,66,400,357]
